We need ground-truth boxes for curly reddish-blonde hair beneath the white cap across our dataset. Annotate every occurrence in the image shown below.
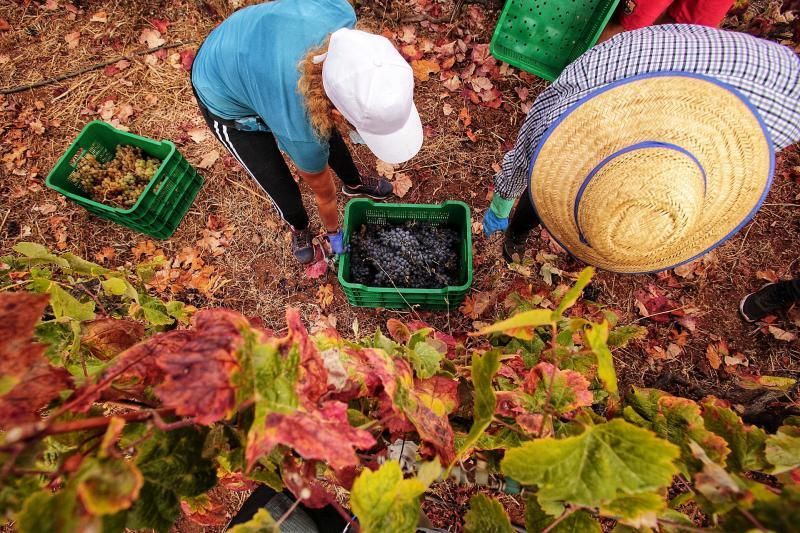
[297,39,346,139]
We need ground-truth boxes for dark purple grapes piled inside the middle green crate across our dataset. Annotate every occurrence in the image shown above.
[350,221,461,289]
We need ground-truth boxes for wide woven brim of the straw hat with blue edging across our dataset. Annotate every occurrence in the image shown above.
[529,72,775,273]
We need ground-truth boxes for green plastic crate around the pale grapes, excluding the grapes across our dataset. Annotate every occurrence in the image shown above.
[46,120,203,239]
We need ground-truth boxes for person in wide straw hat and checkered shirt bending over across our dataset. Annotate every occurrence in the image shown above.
[483,25,800,273]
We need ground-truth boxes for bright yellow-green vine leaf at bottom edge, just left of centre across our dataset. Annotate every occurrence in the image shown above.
[350,461,430,533]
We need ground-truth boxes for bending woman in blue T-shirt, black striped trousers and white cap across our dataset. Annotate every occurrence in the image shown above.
[191,0,422,263]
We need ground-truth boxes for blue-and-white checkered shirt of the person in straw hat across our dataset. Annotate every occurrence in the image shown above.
[495,24,800,199]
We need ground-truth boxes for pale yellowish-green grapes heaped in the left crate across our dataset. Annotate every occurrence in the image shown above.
[69,144,161,208]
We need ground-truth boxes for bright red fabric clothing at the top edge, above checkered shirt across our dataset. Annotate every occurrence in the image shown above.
[622,0,733,31]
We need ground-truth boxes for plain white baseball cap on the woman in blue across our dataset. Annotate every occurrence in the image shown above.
[322,28,422,164]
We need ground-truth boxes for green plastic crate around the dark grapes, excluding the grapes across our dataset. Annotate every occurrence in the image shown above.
[339,198,472,311]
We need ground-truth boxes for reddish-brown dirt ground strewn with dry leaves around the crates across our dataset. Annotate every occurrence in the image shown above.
[0,0,800,528]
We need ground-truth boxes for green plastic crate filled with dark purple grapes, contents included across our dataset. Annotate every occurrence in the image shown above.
[339,198,472,311]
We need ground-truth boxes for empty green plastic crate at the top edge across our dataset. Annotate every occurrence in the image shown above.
[489,0,619,81]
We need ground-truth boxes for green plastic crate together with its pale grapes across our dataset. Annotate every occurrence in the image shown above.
[46,121,203,239]
